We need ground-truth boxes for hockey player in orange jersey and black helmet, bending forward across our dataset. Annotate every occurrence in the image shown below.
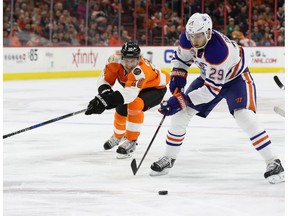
[85,42,170,158]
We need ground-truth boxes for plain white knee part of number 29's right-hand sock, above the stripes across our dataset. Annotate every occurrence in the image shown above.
[234,109,261,136]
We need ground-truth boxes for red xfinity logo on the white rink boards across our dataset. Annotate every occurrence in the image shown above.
[72,49,98,67]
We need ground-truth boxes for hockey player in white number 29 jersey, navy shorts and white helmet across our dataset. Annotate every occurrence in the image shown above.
[151,13,285,184]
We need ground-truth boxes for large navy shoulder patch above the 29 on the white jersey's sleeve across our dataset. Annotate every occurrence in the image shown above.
[204,30,229,65]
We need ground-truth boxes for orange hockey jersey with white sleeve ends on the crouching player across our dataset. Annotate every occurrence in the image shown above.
[97,54,170,104]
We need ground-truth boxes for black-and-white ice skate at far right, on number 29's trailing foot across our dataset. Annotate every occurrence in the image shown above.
[264,159,285,184]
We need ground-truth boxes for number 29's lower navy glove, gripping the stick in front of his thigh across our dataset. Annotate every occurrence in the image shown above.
[158,93,187,116]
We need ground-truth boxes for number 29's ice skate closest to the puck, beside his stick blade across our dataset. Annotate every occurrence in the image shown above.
[150,156,176,176]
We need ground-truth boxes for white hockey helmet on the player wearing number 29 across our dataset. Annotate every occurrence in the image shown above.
[186,13,212,45]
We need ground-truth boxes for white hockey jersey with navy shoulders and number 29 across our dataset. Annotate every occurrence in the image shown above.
[171,30,247,105]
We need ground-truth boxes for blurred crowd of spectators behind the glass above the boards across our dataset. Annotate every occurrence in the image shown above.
[3,0,285,46]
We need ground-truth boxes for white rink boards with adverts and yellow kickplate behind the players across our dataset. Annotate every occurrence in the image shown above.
[3,46,285,80]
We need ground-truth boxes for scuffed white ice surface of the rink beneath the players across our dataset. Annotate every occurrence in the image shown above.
[3,74,285,216]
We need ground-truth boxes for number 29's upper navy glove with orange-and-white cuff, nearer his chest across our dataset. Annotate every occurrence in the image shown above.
[169,68,188,94]
